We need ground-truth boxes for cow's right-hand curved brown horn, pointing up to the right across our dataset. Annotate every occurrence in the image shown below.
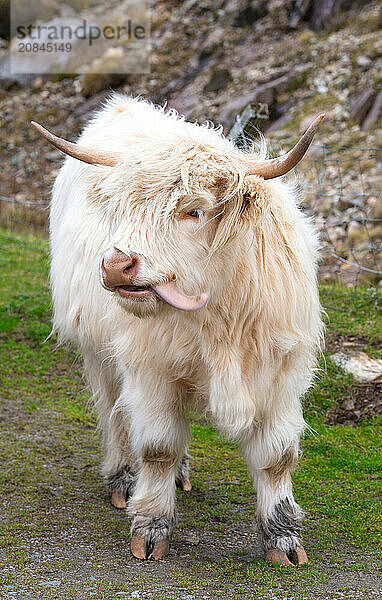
[247,113,326,179]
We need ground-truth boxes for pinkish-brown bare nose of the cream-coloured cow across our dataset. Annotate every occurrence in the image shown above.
[101,248,139,288]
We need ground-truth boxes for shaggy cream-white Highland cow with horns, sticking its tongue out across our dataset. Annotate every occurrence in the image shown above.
[34,95,323,564]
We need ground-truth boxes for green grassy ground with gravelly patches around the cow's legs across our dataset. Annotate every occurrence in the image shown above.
[0,227,381,600]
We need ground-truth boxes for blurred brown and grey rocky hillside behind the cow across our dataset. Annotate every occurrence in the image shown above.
[0,0,382,281]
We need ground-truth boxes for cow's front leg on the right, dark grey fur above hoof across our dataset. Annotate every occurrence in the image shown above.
[243,420,308,565]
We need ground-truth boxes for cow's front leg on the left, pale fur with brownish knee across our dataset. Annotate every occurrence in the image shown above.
[128,381,189,559]
